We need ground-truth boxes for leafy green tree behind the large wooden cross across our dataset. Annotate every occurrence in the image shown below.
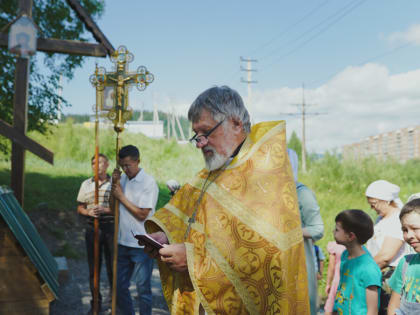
[0,0,104,152]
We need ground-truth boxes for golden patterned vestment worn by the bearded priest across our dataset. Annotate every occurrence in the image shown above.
[146,121,310,315]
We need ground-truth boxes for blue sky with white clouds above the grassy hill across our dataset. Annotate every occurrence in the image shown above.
[58,0,420,153]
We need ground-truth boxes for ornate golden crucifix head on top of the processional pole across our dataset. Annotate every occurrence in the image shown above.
[90,46,154,132]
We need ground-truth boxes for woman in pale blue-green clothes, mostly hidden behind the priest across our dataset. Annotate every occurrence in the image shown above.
[287,149,324,315]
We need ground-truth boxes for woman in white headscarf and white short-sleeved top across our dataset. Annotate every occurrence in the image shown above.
[366,180,407,315]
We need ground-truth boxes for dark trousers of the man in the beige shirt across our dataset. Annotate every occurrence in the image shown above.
[85,223,114,302]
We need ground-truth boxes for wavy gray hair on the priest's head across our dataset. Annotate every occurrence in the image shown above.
[188,85,251,133]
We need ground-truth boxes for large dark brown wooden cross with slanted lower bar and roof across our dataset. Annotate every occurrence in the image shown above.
[0,0,114,207]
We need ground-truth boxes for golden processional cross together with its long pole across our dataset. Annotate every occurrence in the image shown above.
[90,46,154,315]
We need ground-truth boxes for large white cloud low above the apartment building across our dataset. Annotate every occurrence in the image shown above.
[248,63,420,152]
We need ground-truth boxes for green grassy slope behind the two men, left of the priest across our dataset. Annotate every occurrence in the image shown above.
[0,121,204,211]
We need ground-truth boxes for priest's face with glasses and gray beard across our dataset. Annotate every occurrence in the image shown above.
[192,109,236,171]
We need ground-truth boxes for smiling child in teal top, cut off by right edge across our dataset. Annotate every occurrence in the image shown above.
[388,199,420,315]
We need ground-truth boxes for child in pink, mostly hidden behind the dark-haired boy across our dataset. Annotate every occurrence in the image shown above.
[324,242,346,315]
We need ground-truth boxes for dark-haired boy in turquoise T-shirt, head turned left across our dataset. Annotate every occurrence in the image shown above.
[334,209,382,315]
